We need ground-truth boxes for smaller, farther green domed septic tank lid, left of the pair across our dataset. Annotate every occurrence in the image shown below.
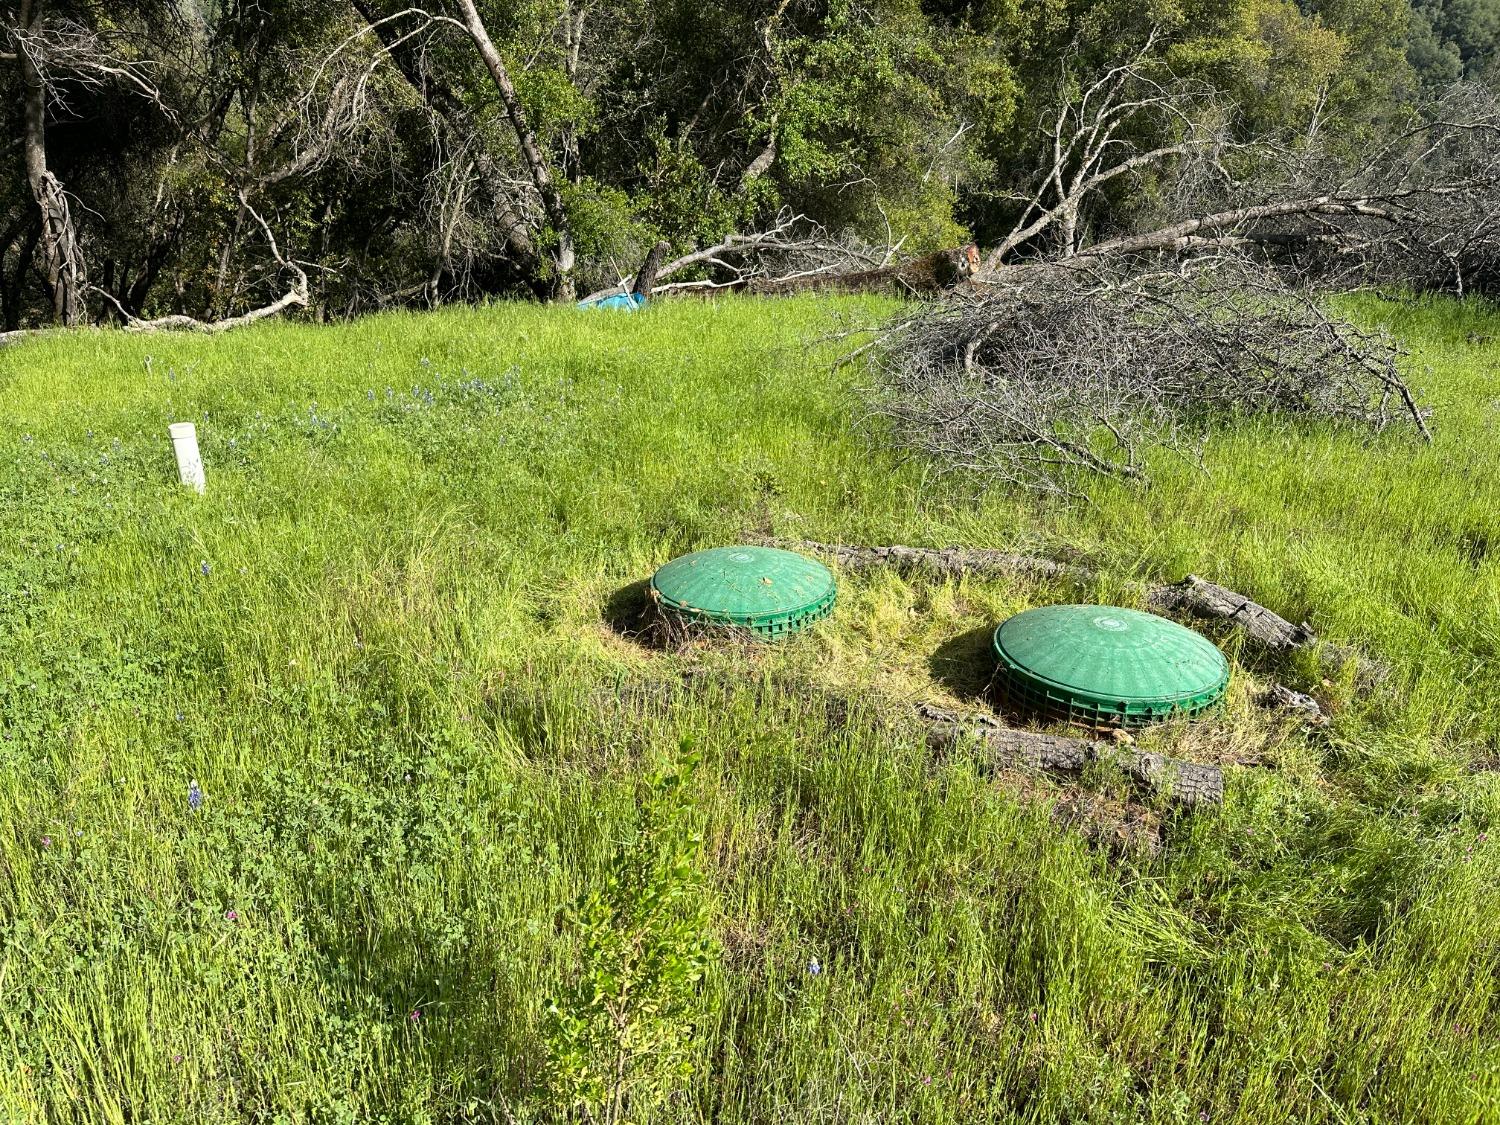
[651,546,836,638]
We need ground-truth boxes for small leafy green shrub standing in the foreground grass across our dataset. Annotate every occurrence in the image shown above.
[546,744,716,1125]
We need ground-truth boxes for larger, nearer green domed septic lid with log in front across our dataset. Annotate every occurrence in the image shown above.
[995,606,1229,726]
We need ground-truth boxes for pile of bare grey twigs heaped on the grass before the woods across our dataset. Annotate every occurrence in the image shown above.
[869,258,1428,495]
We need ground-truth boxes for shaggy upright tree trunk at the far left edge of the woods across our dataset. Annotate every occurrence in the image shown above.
[17,0,86,326]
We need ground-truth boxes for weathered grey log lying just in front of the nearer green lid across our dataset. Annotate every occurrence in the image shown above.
[921,705,1224,809]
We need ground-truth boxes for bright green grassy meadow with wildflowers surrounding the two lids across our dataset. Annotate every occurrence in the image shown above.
[0,299,1500,1125]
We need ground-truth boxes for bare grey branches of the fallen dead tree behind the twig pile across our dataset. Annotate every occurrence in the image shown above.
[986,42,1500,293]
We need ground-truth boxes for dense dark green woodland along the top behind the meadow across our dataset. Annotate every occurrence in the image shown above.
[0,0,1500,329]
